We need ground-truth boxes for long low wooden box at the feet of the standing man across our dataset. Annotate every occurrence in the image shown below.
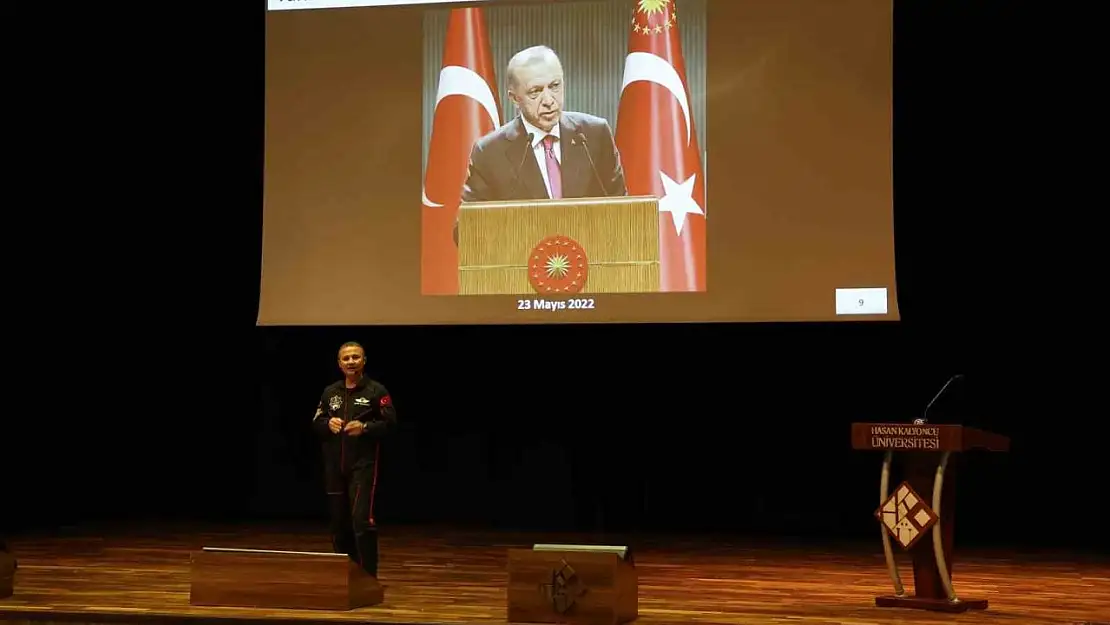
[189,547,384,611]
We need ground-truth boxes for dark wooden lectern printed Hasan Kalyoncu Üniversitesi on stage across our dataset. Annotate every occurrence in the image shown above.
[851,423,1010,613]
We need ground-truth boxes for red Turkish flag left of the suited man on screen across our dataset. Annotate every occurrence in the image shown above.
[421,8,501,295]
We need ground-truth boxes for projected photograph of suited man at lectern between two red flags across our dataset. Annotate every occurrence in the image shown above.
[421,0,706,297]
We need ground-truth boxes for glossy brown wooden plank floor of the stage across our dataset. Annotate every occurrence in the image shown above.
[0,528,1110,625]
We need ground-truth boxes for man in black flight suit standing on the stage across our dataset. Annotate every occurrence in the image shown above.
[312,342,397,577]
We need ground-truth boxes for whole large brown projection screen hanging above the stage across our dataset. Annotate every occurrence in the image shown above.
[259,0,898,325]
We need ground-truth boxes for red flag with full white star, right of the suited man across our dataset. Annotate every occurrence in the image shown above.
[616,0,706,291]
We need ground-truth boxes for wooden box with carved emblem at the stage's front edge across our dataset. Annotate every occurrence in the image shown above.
[507,545,639,625]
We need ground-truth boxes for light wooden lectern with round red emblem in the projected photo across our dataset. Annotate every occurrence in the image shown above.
[458,195,659,295]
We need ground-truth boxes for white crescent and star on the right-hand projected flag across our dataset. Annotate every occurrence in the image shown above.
[620,52,705,235]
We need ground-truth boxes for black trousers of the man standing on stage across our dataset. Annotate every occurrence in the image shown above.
[327,462,377,577]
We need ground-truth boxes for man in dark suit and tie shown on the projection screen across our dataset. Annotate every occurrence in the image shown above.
[462,46,628,202]
